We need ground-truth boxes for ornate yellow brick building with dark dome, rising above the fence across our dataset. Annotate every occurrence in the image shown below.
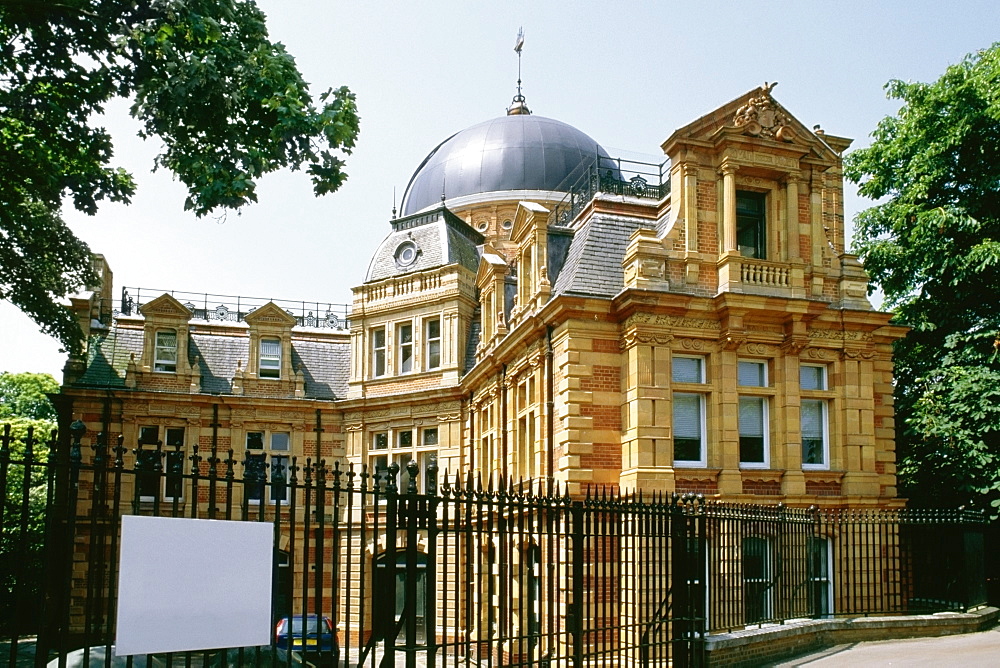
[54,84,905,651]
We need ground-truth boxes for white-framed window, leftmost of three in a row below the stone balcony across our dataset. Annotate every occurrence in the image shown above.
[670,355,708,466]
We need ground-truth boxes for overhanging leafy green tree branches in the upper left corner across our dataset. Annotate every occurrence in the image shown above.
[0,0,358,352]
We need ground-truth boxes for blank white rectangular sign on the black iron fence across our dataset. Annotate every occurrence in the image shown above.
[115,515,274,656]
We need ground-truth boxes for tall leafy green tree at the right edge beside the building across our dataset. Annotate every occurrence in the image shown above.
[845,43,1000,515]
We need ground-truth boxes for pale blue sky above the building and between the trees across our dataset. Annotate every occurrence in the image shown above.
[0,0,1000,379]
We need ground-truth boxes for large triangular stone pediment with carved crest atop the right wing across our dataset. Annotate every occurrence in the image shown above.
[661,82,850,163]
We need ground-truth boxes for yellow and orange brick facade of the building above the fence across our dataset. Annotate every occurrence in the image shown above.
[64,82,903,505]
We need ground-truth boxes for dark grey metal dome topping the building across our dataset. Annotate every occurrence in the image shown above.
[402,115,610,216]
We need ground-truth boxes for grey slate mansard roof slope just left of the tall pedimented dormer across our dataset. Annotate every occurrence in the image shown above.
[553,214,642,298]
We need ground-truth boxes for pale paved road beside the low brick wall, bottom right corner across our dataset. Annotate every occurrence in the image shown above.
[772,626,1000,668]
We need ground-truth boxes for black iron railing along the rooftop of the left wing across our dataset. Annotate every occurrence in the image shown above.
[114,287,351,330]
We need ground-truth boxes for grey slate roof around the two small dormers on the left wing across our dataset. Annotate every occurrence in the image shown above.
[74,323,350,399]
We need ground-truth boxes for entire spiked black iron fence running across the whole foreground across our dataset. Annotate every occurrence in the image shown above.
[0,423,985,666]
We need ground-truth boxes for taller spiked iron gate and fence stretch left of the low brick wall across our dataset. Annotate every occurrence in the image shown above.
[0,423,705,666]
